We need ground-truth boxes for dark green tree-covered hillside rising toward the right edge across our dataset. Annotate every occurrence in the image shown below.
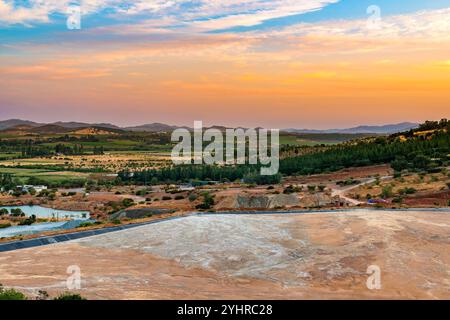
[280,119,450,175]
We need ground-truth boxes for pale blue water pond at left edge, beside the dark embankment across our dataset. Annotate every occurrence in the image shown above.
[0,206,89,238]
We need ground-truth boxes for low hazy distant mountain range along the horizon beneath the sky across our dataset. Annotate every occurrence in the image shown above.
[0,119,419,134]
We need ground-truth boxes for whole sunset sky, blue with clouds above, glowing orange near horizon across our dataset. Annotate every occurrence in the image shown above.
[0,0,450,129]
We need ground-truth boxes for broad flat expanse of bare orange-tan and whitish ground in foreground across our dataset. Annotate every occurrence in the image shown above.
[0,210,450,299]
